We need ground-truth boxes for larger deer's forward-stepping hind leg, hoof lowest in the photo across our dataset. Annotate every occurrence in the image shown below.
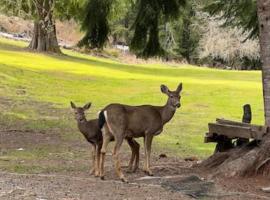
[113,136,127,182]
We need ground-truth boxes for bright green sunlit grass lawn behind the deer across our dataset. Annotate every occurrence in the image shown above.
[0,39,263,157]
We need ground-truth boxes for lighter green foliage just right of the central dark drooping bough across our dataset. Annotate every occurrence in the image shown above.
[159,1,201,63]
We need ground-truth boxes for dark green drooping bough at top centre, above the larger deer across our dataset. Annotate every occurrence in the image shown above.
[130,0,185,58]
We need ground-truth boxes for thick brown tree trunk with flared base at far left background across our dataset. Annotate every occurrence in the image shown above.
[29,0,61,53]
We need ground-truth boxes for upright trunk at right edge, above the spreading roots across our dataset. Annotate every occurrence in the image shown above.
[257,0,270,126]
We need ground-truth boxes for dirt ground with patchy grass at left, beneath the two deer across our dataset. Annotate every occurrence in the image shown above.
[0,97,270,200]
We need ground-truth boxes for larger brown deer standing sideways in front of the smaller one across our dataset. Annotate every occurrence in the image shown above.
[99,83,182,182]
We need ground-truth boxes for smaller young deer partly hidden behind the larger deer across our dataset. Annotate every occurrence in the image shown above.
[70,102,140,176]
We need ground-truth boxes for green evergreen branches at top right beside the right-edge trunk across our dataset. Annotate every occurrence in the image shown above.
[205,0,259,38]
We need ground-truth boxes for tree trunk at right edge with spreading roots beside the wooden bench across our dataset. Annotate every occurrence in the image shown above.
[201,0,270,176]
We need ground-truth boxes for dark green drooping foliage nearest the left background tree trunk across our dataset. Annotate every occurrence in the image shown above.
[78,0,112,48]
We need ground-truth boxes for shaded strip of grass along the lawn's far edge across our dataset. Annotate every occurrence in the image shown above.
[0,41,251,81]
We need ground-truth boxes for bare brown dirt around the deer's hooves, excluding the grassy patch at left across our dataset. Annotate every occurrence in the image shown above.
[0,130,270,200]
